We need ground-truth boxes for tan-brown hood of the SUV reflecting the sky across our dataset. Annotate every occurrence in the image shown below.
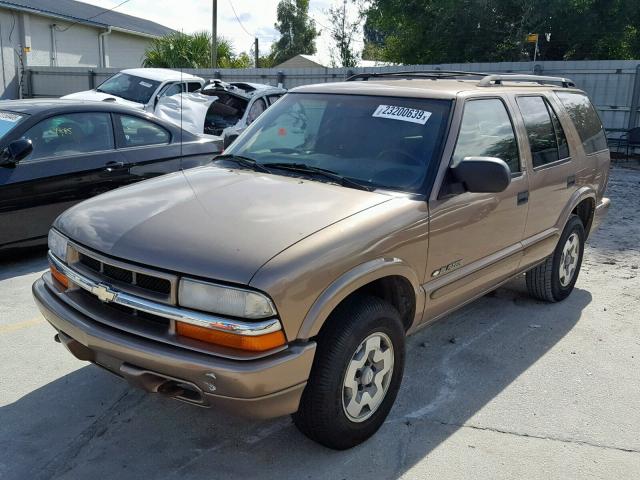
[55,166,392,284]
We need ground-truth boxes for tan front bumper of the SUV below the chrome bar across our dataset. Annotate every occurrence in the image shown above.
[32,279,316,418]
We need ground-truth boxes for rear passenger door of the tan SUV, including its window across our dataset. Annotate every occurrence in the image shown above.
[515,95,577,263]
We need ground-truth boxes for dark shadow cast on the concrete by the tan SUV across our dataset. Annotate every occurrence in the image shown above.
[0,280,591,480]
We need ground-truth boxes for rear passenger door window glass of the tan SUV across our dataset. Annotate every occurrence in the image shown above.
[517,97,568,168]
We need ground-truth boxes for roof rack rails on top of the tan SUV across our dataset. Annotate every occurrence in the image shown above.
[347,70,576,88]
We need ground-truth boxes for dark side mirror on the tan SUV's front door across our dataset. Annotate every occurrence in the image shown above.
[451,157,511,193]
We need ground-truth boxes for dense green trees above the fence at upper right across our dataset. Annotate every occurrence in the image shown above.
[364,0,640,63]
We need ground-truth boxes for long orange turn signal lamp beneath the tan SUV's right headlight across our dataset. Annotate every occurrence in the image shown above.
[176,322,286,352]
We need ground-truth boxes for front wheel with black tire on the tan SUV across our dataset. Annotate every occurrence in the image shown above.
[293,296,405,450]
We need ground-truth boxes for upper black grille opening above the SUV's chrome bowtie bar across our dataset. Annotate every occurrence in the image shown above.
[71,245,177,304]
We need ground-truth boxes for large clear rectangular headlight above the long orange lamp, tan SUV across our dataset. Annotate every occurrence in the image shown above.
[178,278,276,319]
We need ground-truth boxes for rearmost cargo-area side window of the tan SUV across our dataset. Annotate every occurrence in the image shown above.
[556,92,607,154]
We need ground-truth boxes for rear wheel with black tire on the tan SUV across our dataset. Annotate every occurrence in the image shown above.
[526,215,585,302]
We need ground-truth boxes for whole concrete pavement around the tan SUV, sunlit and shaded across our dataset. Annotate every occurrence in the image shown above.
[0,169,640,480]
